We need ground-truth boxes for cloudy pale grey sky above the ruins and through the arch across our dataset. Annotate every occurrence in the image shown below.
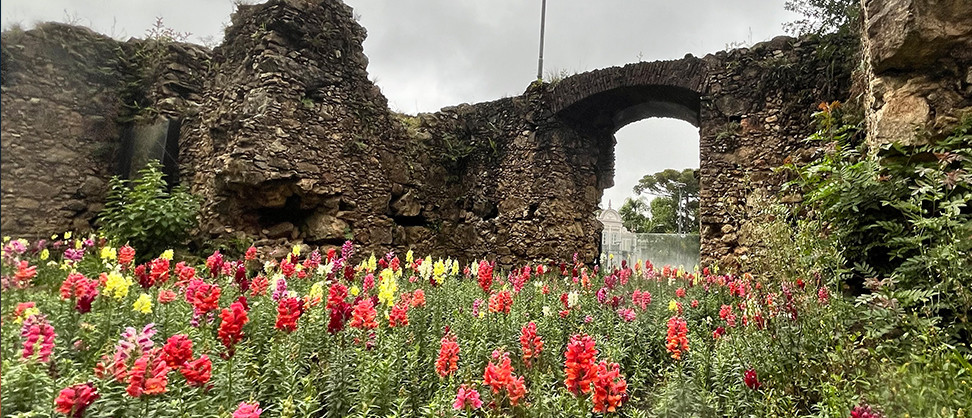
[0,0,795,208]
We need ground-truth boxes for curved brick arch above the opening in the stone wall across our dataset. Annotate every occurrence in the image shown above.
[548,57,705,134]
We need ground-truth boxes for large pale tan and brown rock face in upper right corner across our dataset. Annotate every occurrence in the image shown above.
[864,0,972,147]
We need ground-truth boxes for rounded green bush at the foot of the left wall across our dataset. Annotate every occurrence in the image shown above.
[98,161,199,258]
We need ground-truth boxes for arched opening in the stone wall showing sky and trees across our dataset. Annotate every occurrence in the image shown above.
[598,117,700,268]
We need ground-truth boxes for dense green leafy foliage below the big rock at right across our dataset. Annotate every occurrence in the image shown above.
[789,104,972,342]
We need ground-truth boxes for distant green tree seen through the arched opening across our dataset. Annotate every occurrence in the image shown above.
[634,168,699,233]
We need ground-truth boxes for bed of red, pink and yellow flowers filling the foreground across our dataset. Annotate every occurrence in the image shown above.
[0,235,972,417]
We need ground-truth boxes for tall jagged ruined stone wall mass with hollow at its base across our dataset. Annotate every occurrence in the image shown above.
[180,0,472,253]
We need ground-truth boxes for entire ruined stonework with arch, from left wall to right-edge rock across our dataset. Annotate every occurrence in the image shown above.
[0,0,972,265]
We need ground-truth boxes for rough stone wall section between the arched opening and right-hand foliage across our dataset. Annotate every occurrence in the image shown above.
[699,37,856,266]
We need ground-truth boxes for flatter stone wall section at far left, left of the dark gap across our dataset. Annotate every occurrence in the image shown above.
[0,24,129,237]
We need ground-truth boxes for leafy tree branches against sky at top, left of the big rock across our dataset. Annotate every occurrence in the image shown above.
[783,0,861,36]
